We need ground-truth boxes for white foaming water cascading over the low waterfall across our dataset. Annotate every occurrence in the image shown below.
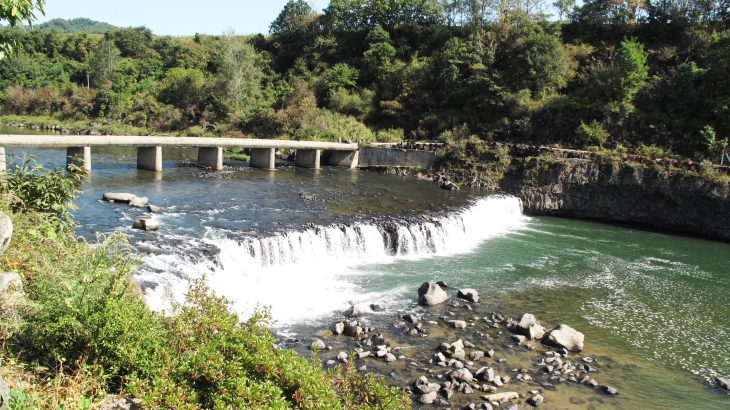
[138,196,527,324]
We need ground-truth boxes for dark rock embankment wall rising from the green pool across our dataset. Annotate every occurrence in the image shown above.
[501,160,730,240]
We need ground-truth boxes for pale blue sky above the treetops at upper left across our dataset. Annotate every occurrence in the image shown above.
[34,0,329,36]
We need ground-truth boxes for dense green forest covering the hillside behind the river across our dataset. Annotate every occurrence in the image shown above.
[0,0,730,159]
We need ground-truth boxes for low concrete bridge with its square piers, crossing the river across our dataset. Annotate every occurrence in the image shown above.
[0,135,359,172]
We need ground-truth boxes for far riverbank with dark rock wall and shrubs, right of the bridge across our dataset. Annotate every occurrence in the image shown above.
[382,144,730,240]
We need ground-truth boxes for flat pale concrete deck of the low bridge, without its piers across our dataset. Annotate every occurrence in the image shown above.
[0,135,358,151]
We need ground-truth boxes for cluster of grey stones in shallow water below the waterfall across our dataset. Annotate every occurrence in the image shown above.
[288,282,619,409]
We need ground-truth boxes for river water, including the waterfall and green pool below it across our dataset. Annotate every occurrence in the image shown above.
[7,139,730,409]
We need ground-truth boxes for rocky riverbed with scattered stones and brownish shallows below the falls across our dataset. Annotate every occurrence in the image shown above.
[280,282,621,409]
